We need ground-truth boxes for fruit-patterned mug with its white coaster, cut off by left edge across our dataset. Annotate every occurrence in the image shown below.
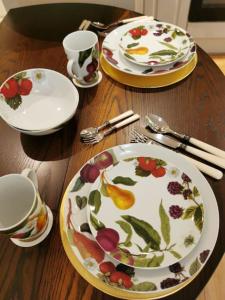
[0,169,52,247]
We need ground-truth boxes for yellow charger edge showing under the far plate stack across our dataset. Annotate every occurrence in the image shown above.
[100,54,198,88]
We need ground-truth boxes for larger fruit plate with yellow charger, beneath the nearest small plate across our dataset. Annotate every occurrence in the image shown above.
[60,144,219,299]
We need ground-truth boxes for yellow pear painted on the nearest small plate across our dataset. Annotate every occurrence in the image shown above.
[106,183,135,210]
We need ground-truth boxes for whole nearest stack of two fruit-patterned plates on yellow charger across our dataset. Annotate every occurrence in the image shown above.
[60,144,219,299]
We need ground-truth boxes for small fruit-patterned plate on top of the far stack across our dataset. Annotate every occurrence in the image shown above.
[119,21,191,66]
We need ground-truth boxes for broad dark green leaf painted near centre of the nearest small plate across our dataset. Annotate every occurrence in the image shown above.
[121,215,161,250]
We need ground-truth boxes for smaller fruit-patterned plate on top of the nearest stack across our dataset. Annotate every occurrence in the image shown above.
[84,146,204,269]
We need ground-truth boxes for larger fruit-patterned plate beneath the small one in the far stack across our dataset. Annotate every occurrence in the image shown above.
[102,21,196,77]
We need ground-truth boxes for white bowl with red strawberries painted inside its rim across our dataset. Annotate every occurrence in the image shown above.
[0,69,79,135]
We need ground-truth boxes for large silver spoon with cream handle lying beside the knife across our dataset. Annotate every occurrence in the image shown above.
[145,114,225,158]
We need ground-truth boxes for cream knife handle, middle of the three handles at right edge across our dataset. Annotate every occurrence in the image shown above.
[184,144,225,169]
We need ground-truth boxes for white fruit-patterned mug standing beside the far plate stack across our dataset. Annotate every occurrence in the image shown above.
[63,30,99,85]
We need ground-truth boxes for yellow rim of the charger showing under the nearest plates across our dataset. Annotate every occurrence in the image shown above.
[59,179,201,300]
